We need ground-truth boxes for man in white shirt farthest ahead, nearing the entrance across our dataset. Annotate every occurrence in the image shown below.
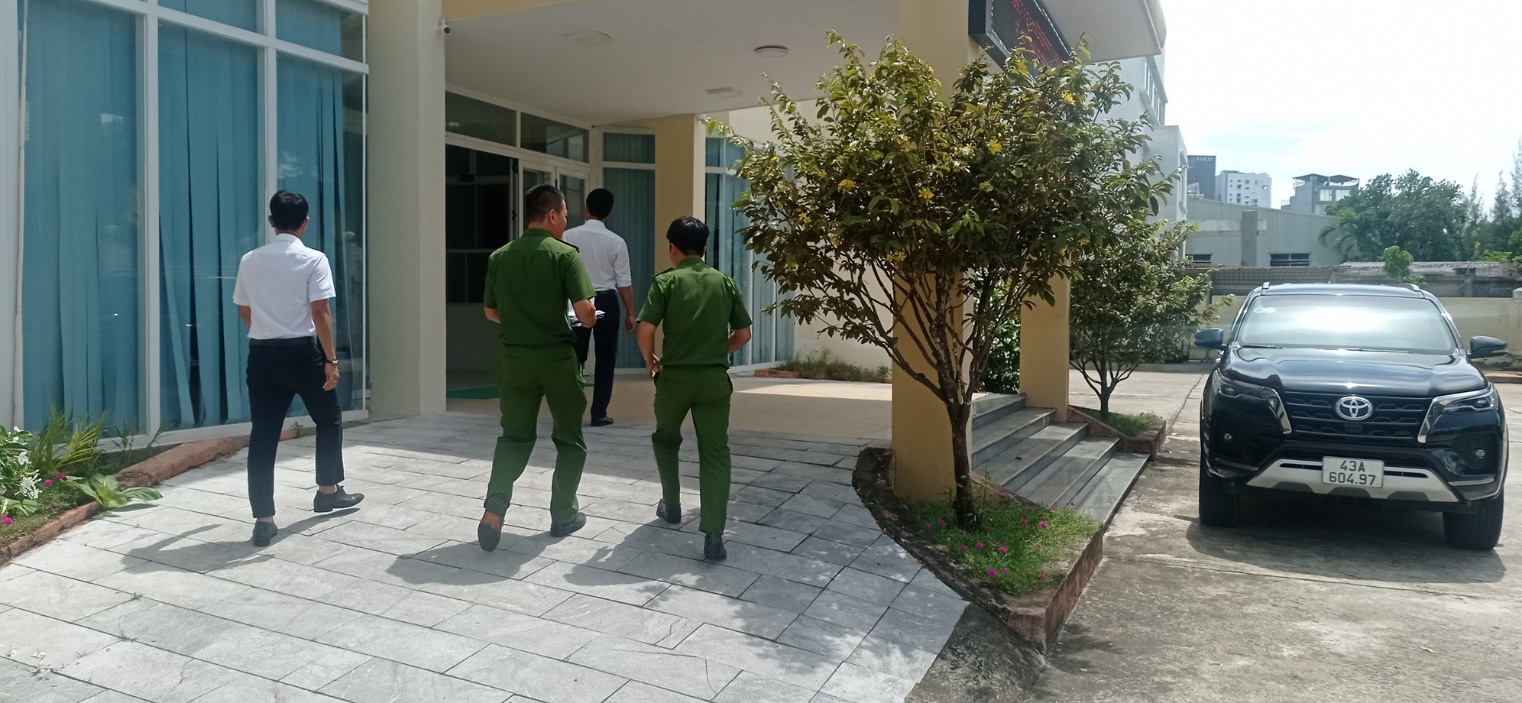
[565,189,635,428]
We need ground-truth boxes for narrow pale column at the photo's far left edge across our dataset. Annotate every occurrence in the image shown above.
[0,0,21,428]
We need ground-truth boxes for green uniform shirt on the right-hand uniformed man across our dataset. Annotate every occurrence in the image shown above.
[639,257,750,368]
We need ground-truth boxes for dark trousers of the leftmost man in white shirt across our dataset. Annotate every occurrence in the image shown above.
[248,338,344,517]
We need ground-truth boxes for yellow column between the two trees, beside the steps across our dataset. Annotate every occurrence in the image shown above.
[1020,278,1071,423]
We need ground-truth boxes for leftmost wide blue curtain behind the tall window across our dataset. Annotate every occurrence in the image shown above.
[21,0,143,429]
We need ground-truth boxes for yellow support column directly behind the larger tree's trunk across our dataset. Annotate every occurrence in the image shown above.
[888,0,980,499]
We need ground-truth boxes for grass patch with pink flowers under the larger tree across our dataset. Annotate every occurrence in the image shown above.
[909,498,1099,595]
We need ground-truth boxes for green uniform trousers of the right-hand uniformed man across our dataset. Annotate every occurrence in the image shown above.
[650,367,735,536]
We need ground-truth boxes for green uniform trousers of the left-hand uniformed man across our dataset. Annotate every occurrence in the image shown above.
[486,344,586,522]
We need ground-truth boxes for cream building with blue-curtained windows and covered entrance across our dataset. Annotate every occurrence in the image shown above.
[0,0,1166,490]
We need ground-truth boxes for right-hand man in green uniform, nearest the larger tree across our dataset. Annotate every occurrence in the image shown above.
[639,218,750,561]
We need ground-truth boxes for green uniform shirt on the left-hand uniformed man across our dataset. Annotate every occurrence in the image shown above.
[484,230,595,347]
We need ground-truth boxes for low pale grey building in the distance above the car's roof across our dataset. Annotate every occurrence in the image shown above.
[1184,201,1344,268]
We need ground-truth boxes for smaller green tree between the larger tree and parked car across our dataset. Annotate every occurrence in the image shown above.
[1070,220,1221,415]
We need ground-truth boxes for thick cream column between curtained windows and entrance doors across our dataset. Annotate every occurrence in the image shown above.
[367,0,446,417]
